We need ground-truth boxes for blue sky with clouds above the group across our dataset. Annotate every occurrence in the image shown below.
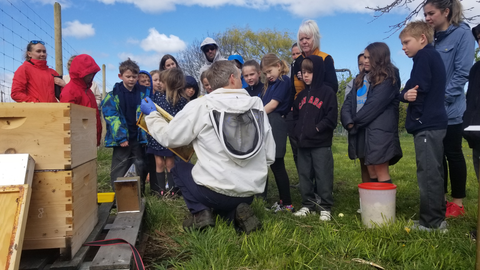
[0,0,480,100]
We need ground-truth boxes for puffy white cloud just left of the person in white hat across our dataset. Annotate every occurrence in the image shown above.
[140,28,187,54]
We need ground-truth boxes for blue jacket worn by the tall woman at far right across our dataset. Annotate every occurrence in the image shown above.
[434,22,475,125]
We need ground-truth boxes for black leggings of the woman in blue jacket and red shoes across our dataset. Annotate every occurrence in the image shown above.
[443,124,467,199]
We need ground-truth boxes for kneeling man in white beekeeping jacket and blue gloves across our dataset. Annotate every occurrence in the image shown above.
[141,61,275,233]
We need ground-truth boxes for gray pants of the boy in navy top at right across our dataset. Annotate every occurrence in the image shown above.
[413,129,446,228]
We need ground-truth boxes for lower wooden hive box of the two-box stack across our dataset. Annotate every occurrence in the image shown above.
[23,160,98,258]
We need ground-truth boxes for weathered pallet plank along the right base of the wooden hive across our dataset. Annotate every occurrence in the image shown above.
[50,203,113,270]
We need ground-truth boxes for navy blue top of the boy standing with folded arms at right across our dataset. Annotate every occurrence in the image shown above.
[400,44,448,134]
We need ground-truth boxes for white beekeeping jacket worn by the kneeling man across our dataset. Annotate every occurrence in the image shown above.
[145,88,275,197]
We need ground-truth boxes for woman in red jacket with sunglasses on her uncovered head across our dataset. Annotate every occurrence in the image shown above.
[11,40,65,102]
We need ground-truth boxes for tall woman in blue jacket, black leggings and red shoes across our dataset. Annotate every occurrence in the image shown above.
[423,0,475,217]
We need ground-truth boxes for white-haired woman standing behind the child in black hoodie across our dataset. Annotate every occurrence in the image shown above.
[293,20,338,98]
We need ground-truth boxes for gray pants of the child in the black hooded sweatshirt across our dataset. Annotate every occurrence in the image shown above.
[298,147,333,211]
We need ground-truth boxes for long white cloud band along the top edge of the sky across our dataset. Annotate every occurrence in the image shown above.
[94,0,478,18]
